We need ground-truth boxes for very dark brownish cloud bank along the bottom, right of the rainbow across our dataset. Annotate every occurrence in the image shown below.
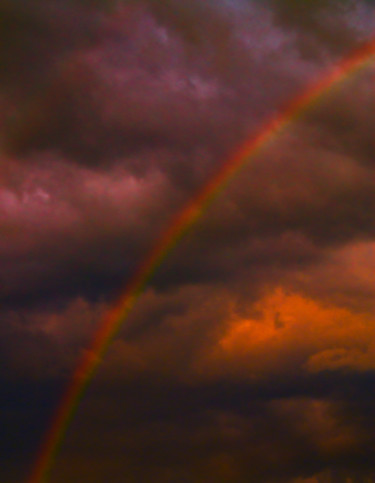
[43,379,373,482]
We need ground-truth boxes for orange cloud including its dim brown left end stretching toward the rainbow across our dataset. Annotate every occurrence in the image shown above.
[99,287,375,381]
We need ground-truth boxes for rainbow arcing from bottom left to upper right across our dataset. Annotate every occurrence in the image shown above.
[28,39,375,483]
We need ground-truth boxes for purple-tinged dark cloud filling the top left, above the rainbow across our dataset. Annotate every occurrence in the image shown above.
[3,1,362,165]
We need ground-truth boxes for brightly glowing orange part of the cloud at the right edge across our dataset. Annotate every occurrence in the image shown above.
[197,288,375,379]
